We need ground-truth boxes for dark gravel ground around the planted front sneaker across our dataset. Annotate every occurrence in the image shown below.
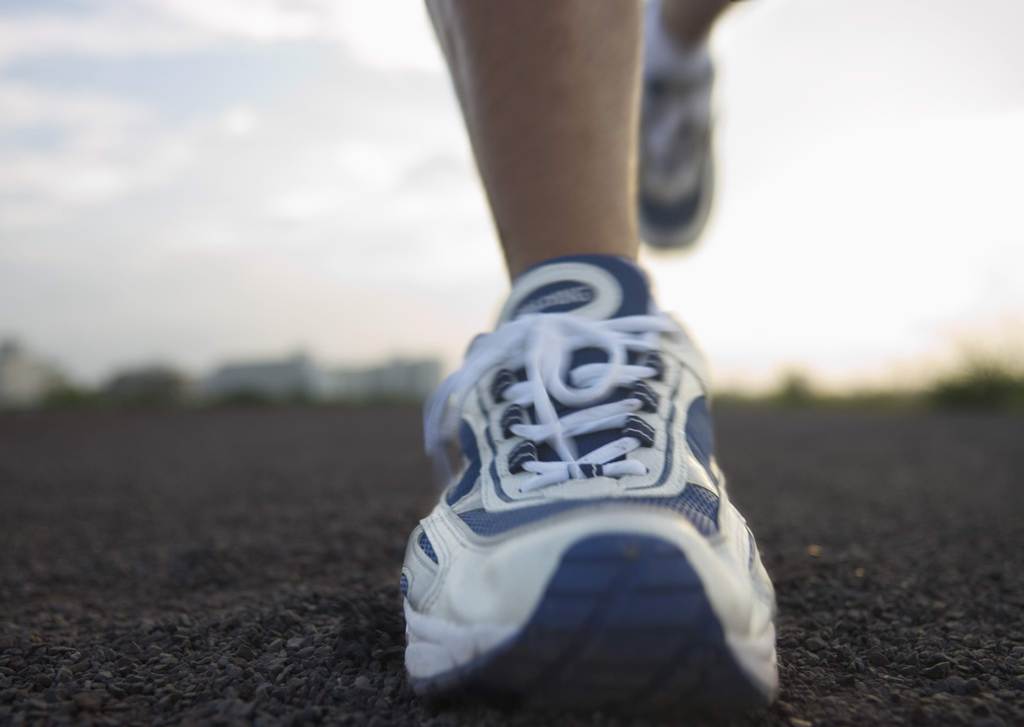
[0,409,1024,727]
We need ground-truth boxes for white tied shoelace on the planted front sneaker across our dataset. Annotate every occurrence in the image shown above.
[424,313,678,491]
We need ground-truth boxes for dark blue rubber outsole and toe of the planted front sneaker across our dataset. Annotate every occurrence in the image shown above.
[414,533,769,713]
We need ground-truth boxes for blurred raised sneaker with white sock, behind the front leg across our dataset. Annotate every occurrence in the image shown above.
[637,0,715,249]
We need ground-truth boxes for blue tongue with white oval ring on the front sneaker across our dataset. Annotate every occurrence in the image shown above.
[498,255,651,325]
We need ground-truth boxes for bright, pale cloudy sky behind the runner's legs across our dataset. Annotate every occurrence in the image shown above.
[0,0,1024,393]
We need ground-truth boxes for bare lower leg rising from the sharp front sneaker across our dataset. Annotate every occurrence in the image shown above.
[427,0,641,276]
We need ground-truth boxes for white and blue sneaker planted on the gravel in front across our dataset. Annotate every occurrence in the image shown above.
[400,255,778,712]
